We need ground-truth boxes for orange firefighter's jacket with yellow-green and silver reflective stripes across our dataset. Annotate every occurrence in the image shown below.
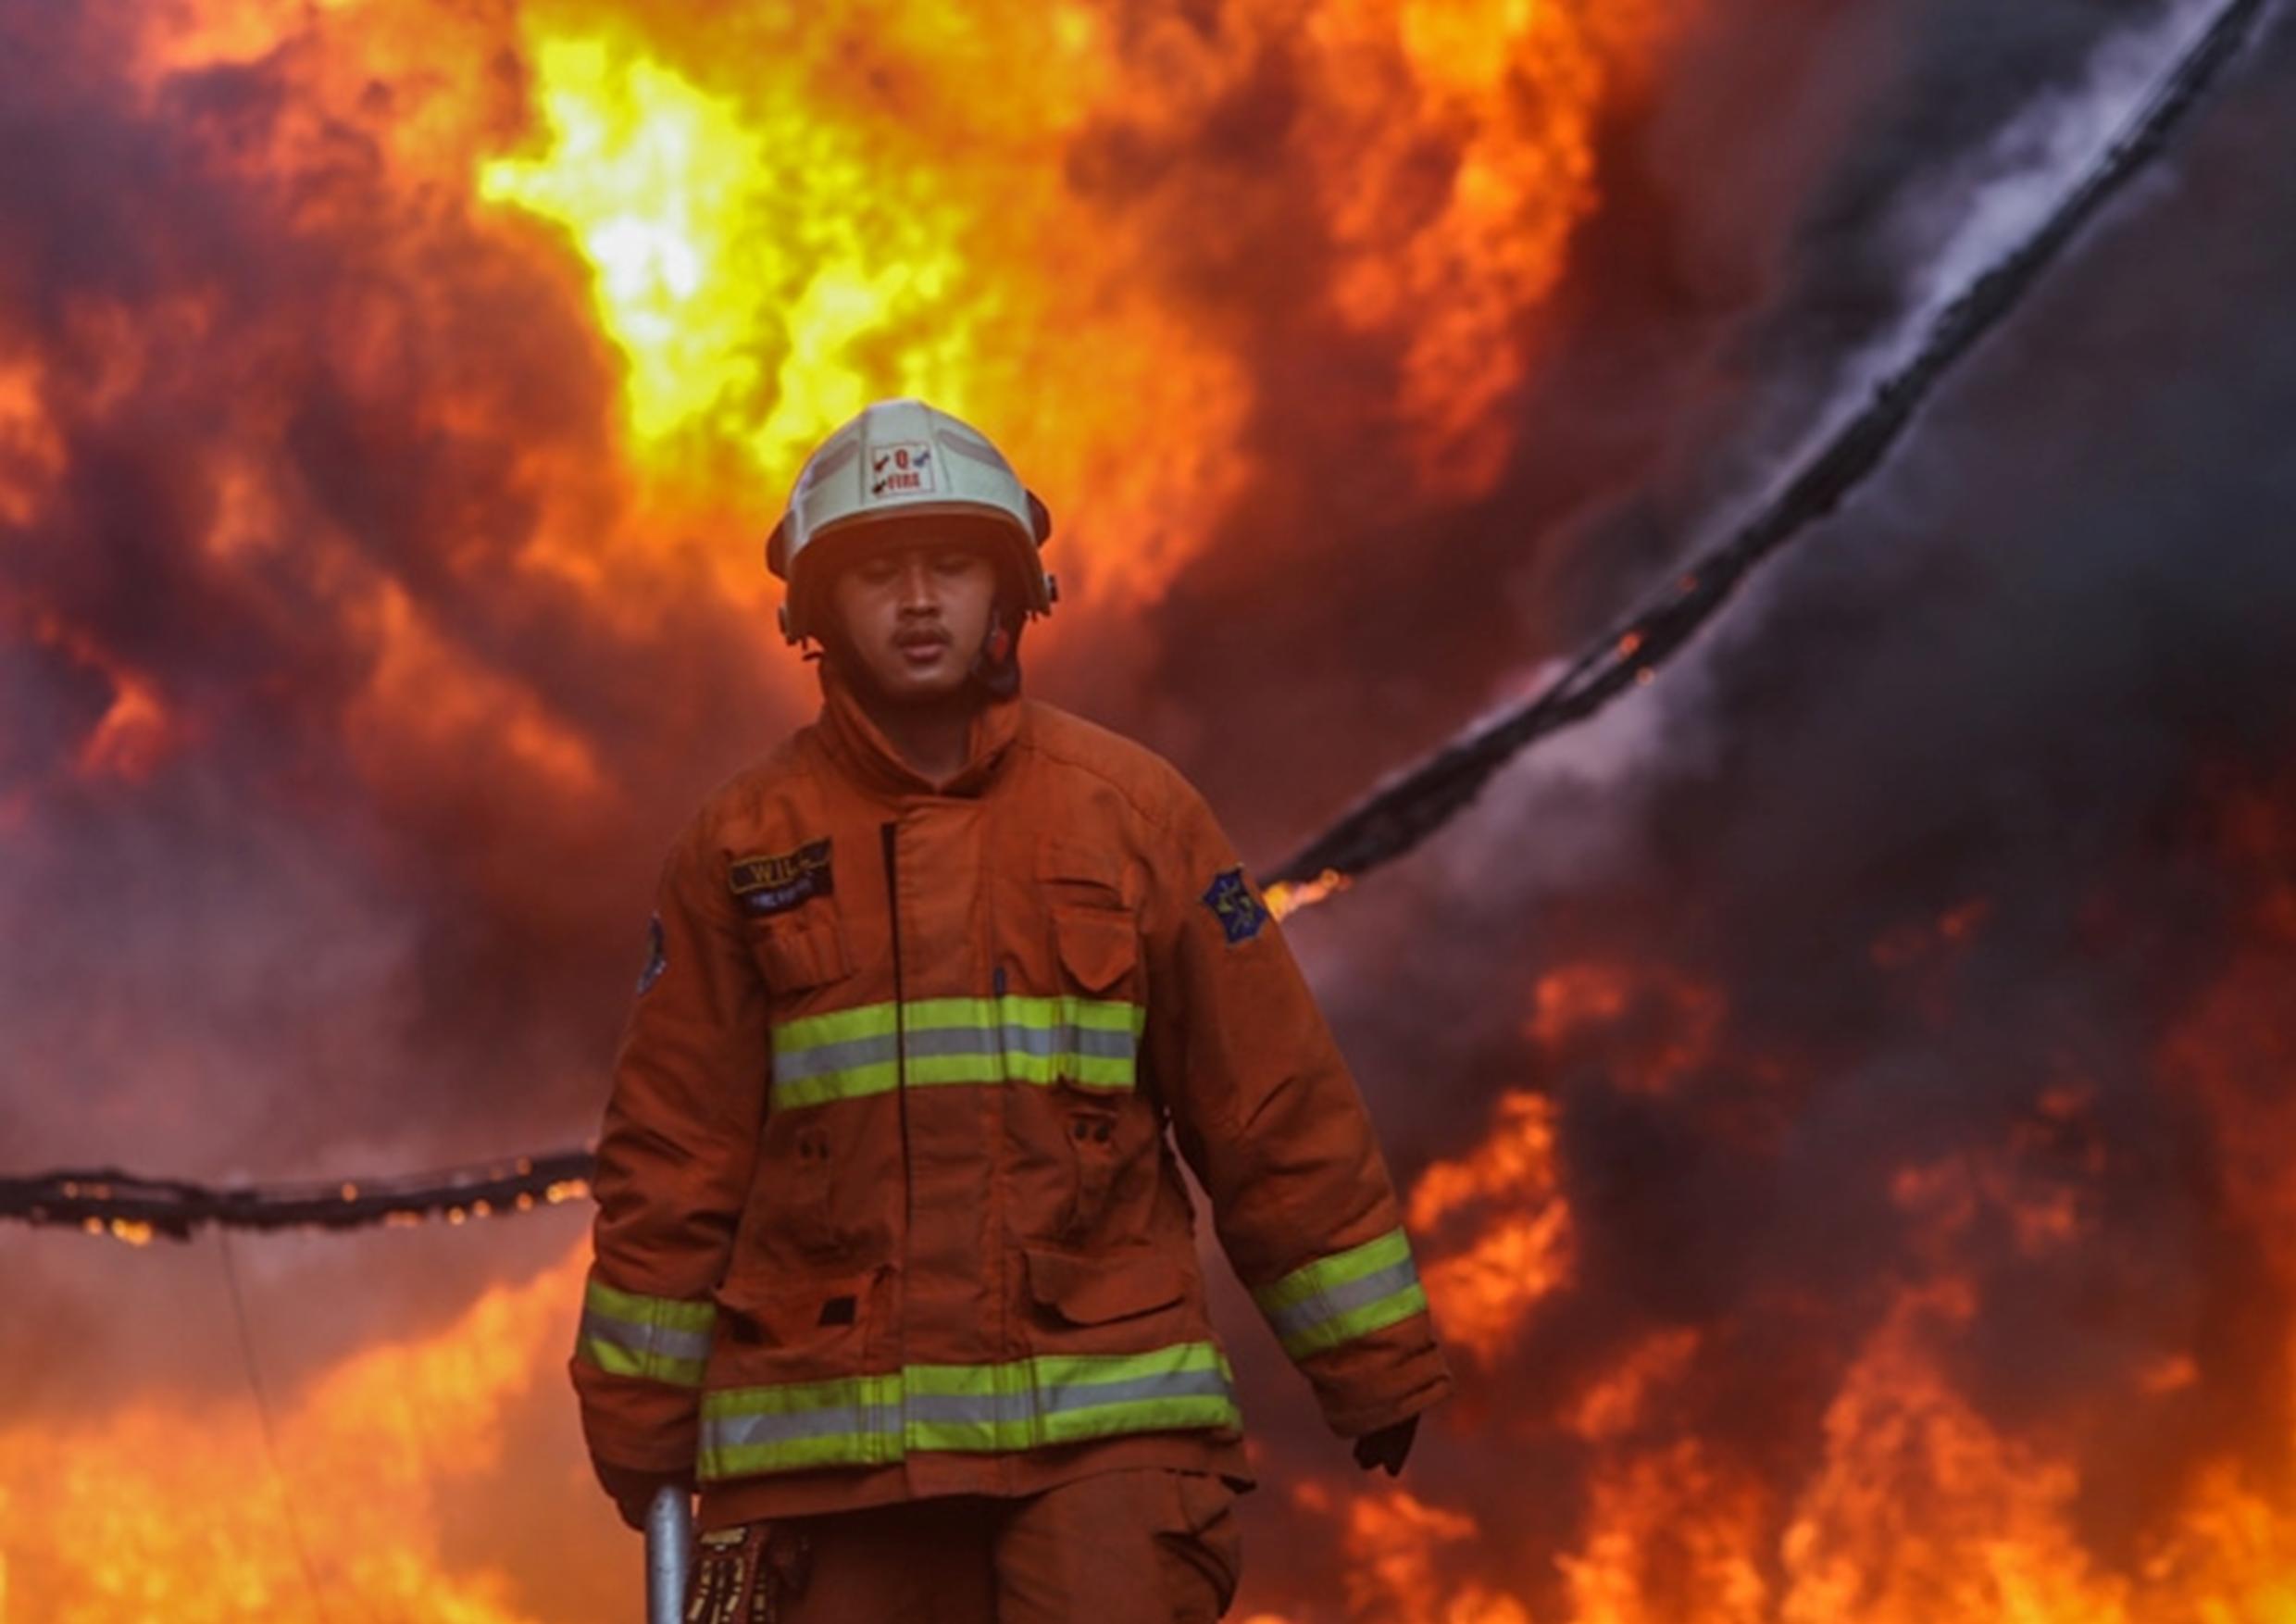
[572,662,1451,1528]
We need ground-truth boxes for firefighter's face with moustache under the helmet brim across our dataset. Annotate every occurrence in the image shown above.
[829,535,996,703]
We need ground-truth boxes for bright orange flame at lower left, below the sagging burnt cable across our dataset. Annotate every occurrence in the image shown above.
[0,1247,610,1624]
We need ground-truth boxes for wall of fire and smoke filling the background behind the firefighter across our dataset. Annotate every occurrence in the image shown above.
[0,0,2296,1624]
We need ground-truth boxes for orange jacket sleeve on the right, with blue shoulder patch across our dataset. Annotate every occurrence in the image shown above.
[1146,774,1451,1438]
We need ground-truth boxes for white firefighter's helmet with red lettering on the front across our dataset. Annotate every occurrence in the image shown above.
[765,400,1058,643]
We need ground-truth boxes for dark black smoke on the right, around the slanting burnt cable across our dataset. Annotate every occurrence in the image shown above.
[1230,6,2296,1618]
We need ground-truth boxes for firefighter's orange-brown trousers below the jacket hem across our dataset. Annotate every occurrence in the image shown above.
[687,1468,1242,1624]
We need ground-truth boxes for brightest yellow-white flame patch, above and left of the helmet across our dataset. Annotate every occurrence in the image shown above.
[480,37,960,468]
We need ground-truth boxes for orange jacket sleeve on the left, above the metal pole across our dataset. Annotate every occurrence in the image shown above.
[572,818,769,1472]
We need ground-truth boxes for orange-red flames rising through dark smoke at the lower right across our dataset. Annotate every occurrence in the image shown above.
[1254,881,2296,1624]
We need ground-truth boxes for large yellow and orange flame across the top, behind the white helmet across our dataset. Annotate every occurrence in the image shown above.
[103,0,1666,615]
